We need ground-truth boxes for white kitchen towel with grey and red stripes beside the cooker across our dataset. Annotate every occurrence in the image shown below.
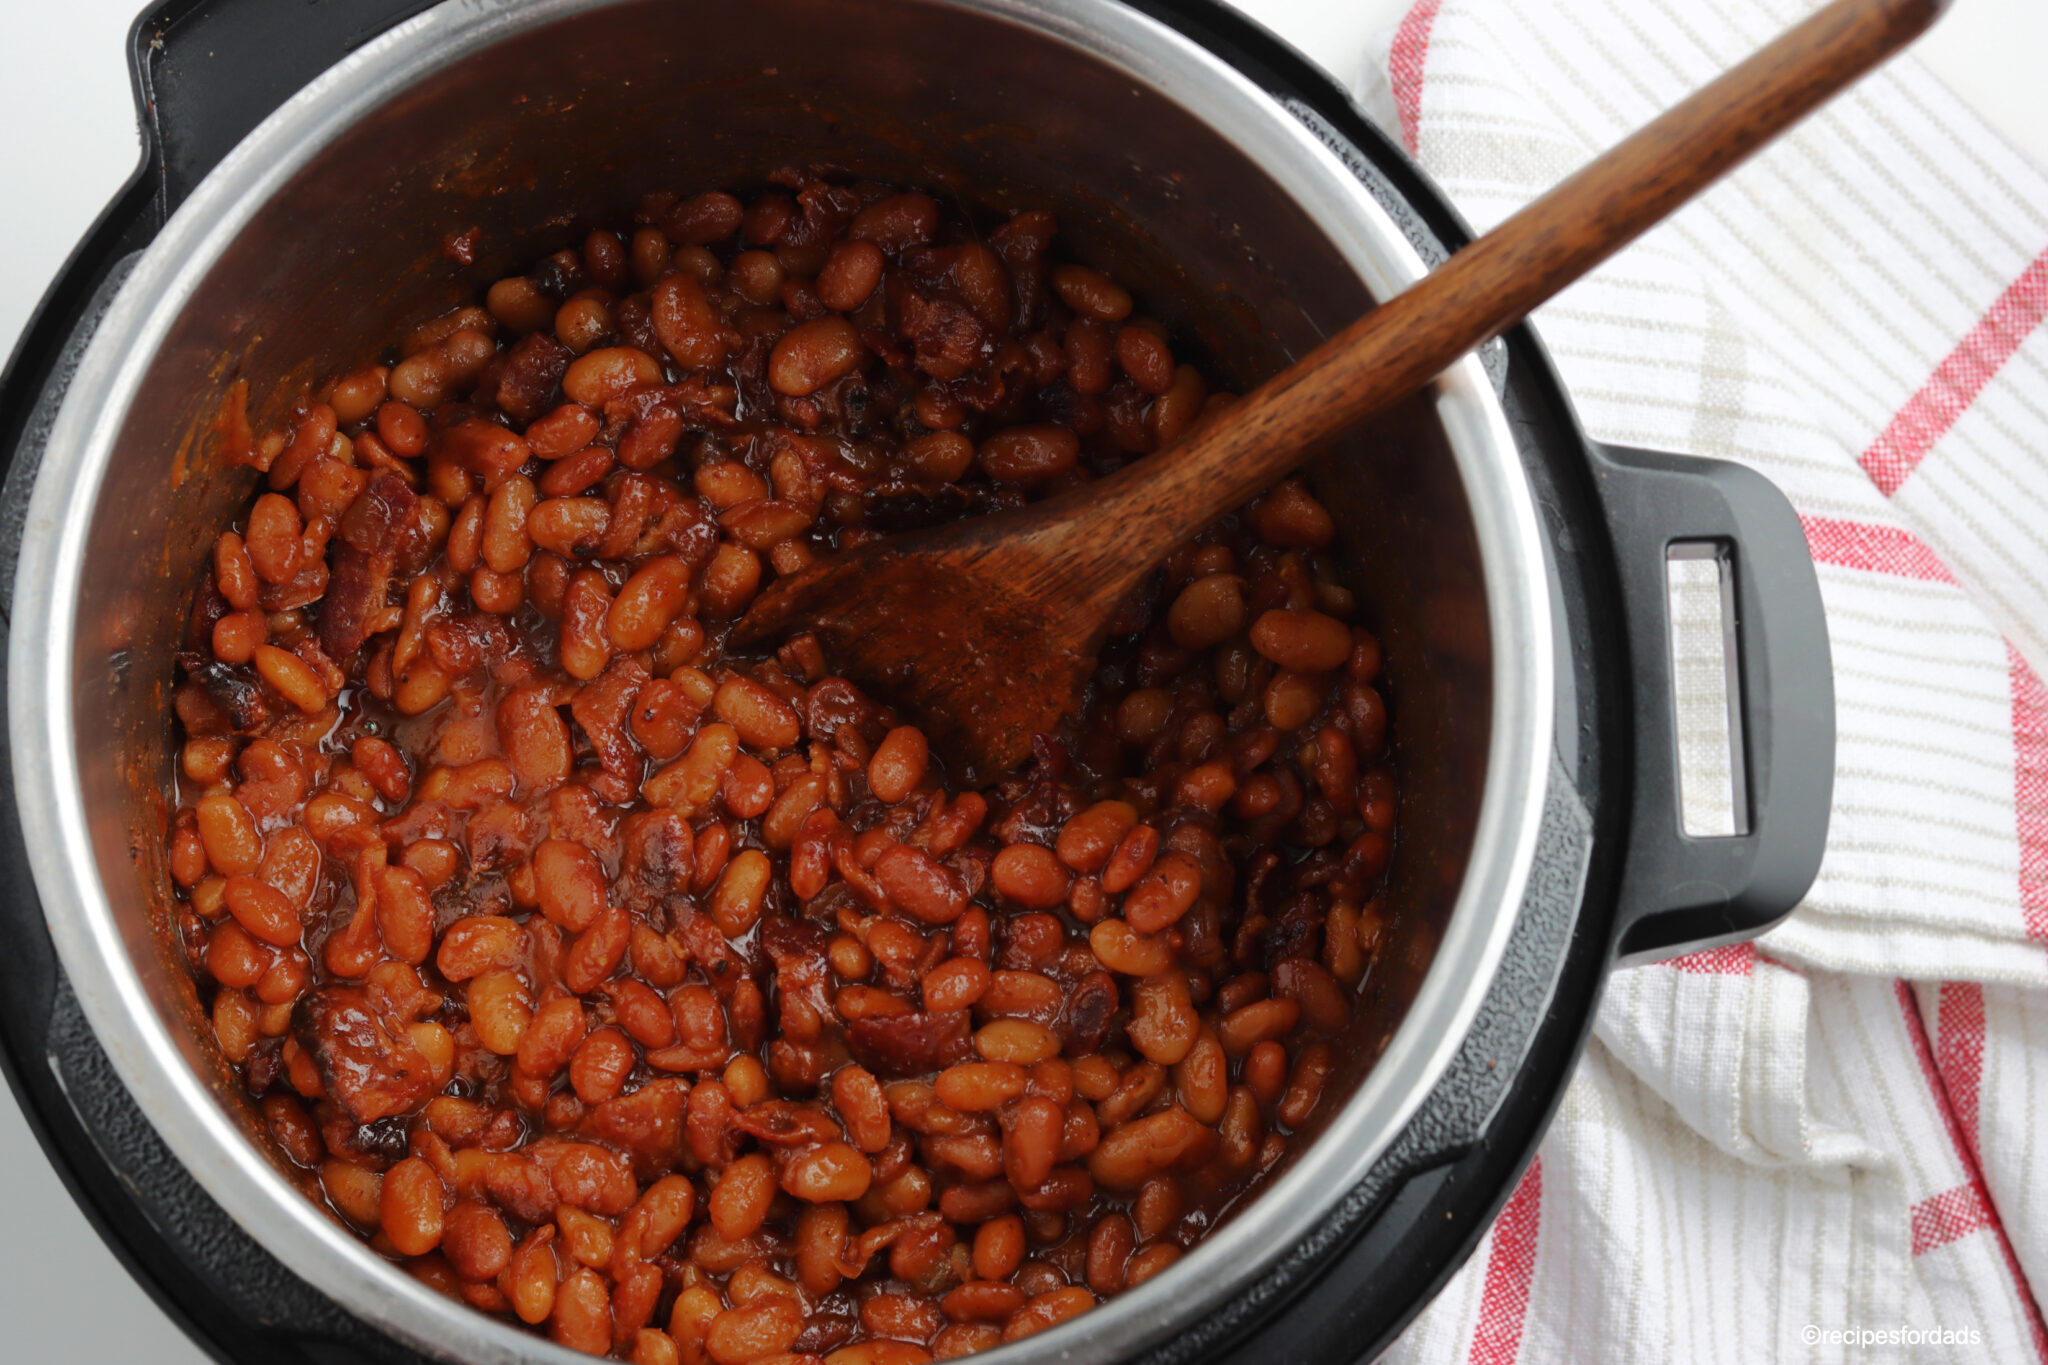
[1360,0,2048,1365]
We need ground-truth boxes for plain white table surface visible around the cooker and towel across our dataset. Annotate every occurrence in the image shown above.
[0,0,2048,1365]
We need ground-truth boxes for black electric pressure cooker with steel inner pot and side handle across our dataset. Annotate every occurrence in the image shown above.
[0,0,1833,1365]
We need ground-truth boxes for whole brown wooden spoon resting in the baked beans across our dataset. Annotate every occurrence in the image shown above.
[735,0,1948,782]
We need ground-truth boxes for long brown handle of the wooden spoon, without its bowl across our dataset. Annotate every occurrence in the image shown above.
[1090,0,1948,559]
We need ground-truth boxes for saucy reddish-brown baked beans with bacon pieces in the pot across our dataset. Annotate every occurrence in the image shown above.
[166,174,1397,1365]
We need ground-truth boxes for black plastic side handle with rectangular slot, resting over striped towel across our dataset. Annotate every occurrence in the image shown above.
[1587,444,1835,964]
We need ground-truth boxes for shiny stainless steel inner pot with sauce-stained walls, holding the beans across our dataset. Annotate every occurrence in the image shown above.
[8,0,1552,1363]
